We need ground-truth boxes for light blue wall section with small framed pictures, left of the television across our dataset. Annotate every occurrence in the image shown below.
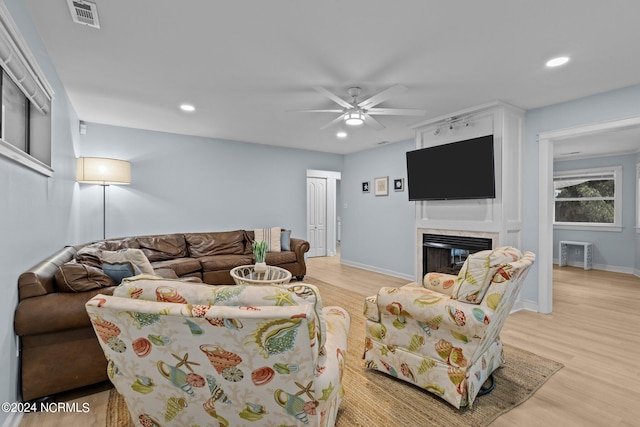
[341,139,416,280]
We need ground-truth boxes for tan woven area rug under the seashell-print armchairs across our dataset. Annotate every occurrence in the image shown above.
[106,277,563,427]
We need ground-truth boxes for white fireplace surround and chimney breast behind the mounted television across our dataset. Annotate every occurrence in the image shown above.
[415,102,524,281]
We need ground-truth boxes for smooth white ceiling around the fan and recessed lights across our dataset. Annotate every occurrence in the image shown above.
[24,0,640,153]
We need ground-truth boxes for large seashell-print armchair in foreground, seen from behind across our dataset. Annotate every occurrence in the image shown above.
[86,275,350,427]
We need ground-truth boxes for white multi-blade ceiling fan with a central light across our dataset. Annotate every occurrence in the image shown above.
[298,85,426,130]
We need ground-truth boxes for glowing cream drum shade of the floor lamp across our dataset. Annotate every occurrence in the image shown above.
[76,157,131,185]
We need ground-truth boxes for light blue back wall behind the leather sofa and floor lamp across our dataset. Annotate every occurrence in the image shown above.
[79,123,343,239]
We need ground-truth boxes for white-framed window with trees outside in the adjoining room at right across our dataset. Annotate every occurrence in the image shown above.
[553,166,622,232]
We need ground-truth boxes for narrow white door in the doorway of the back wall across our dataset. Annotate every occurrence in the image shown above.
[307,178,327,257]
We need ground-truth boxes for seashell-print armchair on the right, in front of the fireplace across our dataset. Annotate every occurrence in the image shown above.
[364,247,535,408]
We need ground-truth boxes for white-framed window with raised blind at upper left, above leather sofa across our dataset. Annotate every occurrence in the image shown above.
[0,3,53,176]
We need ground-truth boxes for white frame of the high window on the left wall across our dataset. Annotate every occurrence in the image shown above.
[0,2,54,177]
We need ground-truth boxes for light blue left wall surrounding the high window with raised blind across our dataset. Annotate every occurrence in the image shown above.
[0,0,82,424]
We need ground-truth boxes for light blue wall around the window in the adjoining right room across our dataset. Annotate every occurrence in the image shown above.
[553,155,640,273]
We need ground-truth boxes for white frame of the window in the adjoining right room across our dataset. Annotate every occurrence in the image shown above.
[552,166,622,231]
